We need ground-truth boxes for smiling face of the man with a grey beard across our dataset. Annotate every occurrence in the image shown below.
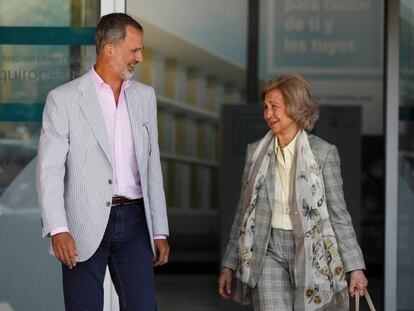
[110,26,144,80]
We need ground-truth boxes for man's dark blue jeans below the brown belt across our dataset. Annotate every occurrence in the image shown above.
[62,200,156,311]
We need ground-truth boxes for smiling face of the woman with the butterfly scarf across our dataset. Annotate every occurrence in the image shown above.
[263,89,299,136]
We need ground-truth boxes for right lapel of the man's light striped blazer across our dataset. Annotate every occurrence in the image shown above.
[125,85,143,172]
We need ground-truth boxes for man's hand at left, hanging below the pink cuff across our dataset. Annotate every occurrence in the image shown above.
[52,232,78,269]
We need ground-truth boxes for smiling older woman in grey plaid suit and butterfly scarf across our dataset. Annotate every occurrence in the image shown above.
[218,75,368,311]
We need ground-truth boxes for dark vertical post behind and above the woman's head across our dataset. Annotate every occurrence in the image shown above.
[246,0,260,104]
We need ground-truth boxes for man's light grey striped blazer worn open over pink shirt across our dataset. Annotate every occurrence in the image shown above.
[37,72,168,261]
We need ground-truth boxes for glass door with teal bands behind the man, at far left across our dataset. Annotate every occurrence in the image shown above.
[0,0,100,311]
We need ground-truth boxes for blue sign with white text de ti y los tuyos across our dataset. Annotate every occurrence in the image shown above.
[265,0,384,76]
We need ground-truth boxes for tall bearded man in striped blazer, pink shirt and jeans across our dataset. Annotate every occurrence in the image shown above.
[37,13,169,311]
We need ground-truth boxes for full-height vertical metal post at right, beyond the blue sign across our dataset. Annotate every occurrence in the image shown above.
[384,0,400,311]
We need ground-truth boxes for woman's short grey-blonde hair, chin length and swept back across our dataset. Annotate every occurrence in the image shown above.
[262,74,319,131]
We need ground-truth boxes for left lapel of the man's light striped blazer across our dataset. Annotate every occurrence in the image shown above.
[79,73,112,164]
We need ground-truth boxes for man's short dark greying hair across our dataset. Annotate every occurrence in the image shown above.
[95,13,144,55]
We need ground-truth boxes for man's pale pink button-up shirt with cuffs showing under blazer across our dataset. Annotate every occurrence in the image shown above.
[50,67,166,239]
